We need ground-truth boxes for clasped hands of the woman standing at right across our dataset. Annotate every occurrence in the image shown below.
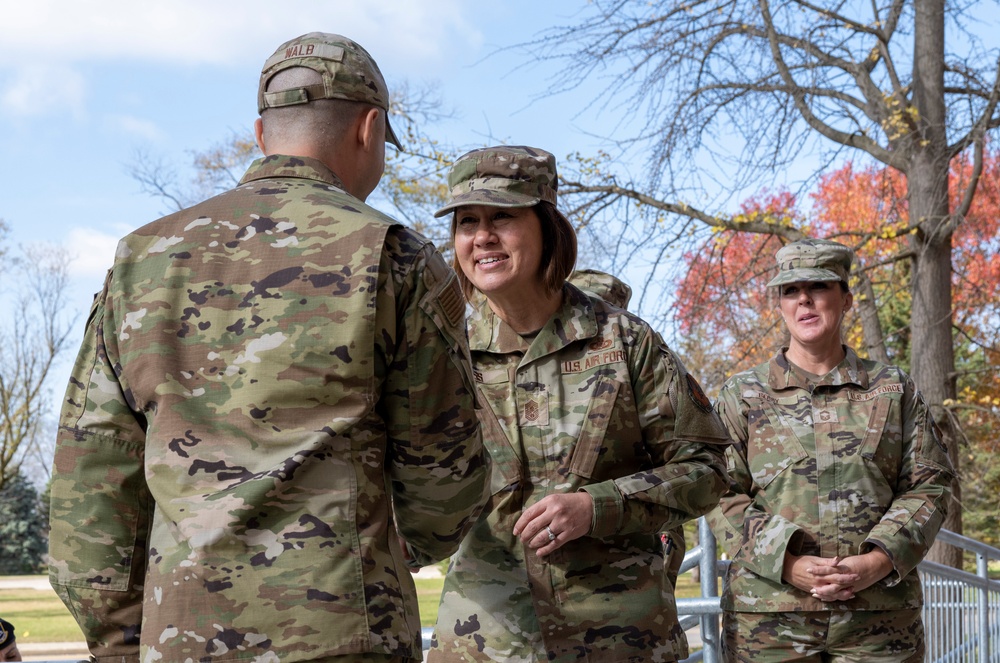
[781,548,892,601]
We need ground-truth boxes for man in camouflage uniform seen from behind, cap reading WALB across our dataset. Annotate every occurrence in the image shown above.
[50,33,488,663]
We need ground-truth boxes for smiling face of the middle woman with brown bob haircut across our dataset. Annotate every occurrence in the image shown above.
[455,205,545,302]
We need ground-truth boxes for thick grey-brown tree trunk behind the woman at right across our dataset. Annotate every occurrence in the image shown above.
[907,0,962,566]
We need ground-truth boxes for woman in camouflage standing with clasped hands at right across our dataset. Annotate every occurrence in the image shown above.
[709,239,953,663]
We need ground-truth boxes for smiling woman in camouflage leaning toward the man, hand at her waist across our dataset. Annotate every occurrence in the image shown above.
[428,147,728,663]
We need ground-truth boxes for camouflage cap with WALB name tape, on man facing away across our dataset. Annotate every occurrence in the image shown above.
[257,32,403,150]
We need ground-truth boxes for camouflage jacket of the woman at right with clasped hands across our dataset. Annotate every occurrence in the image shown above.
[709,348,953,612]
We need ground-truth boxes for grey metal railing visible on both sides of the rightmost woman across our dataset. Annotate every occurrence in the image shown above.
[677,518,1000,663]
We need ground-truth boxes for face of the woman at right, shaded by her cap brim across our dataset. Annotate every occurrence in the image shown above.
[779,281,854,355]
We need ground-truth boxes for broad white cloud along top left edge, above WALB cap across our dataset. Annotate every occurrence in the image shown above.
[0,0,481,73]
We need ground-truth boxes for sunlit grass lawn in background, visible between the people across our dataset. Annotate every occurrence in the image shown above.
[0,573,700,642]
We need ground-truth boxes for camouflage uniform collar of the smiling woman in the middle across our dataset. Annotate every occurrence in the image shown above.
[469,283,597,363]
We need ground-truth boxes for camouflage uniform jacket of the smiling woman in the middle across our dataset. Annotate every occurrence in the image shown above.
[428,285,728,663]
